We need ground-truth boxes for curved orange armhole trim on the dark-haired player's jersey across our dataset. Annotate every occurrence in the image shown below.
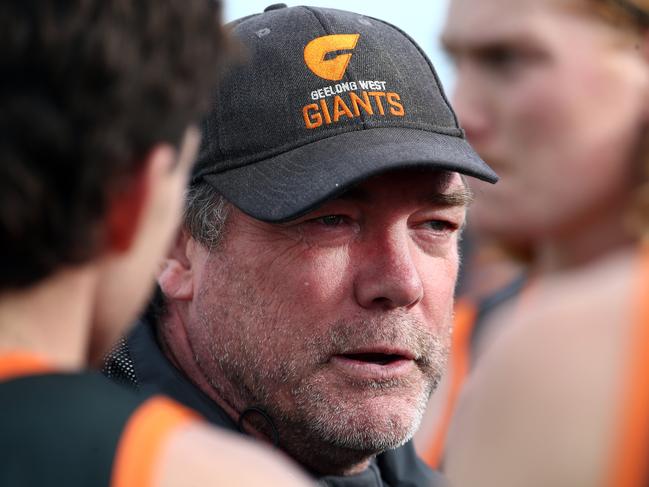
[111,396,199,487]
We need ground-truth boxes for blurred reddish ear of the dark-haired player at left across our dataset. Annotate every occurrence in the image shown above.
[106,144,176,253]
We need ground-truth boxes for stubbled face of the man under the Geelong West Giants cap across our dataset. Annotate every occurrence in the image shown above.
[186,172,468,467]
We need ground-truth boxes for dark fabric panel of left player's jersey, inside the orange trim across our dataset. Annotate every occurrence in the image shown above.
[0,372,146,487]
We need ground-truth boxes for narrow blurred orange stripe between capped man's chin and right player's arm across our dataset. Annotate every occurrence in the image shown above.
[423,300,478,469]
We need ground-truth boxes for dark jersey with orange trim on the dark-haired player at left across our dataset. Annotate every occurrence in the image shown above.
[0,354,196,487]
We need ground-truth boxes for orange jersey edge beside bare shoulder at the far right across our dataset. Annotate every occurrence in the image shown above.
[606,245,649,487]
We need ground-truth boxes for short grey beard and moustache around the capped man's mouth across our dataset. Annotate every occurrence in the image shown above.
[205,315,448,456]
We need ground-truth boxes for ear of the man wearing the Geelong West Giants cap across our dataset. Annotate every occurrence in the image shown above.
[158,228,194,301]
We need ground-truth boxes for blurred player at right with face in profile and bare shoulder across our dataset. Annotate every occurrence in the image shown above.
[420,0,649,487]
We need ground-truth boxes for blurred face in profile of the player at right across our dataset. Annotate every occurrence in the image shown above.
[443,0,647,245]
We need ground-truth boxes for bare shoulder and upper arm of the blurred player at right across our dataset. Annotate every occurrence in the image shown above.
[447,250,636,487]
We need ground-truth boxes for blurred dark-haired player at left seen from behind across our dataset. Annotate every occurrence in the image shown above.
[0,0,312,487]
